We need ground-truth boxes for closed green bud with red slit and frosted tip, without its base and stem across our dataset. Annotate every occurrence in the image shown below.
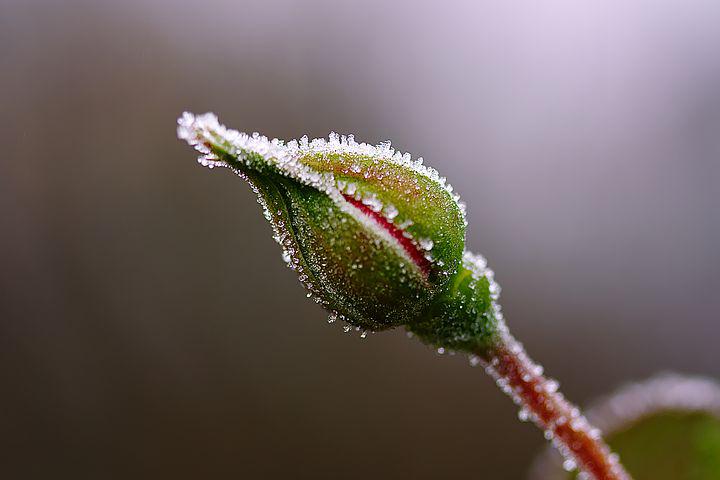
[178,113,466,330]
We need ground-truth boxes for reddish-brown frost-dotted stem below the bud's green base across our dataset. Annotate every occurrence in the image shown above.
[480,332,630,480]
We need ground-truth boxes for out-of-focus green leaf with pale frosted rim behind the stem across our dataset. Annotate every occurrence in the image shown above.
[530,375,720,480]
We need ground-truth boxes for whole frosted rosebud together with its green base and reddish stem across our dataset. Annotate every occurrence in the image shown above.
[178,113,632,480]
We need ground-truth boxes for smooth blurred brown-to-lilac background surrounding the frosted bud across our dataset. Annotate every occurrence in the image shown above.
[0,0,720,479]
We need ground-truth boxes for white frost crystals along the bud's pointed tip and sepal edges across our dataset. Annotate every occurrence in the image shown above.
[177,112,456,276]
